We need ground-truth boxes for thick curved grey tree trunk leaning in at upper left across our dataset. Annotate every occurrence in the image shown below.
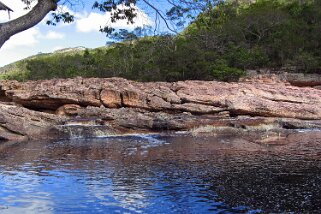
[0,0,57,48]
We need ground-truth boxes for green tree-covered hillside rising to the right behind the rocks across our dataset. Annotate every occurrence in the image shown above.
[0,0,321,81]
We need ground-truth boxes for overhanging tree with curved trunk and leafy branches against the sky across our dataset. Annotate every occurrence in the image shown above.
[0,0,219,48]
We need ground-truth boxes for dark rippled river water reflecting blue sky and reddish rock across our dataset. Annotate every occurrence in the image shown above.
[0,133,321,213]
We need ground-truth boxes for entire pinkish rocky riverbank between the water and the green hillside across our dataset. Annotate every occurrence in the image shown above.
[0,78,321,142]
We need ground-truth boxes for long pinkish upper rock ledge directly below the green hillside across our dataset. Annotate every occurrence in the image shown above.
[0,78,321,120]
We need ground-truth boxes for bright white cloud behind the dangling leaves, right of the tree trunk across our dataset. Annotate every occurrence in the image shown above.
[76,5,152,33]
